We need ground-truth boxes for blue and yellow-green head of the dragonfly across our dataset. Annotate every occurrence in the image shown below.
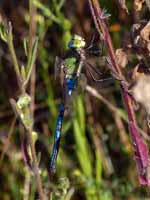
[68,35,86,49]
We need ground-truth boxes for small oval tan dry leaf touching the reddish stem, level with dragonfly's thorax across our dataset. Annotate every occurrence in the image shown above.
[116,49,128,68]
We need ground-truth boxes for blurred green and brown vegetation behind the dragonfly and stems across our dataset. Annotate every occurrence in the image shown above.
[0,0,149,200]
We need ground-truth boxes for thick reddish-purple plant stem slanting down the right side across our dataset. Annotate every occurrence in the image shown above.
[88,0,150,185]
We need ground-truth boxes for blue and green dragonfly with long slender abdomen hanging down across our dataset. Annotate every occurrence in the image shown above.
[50,35,110,176]
